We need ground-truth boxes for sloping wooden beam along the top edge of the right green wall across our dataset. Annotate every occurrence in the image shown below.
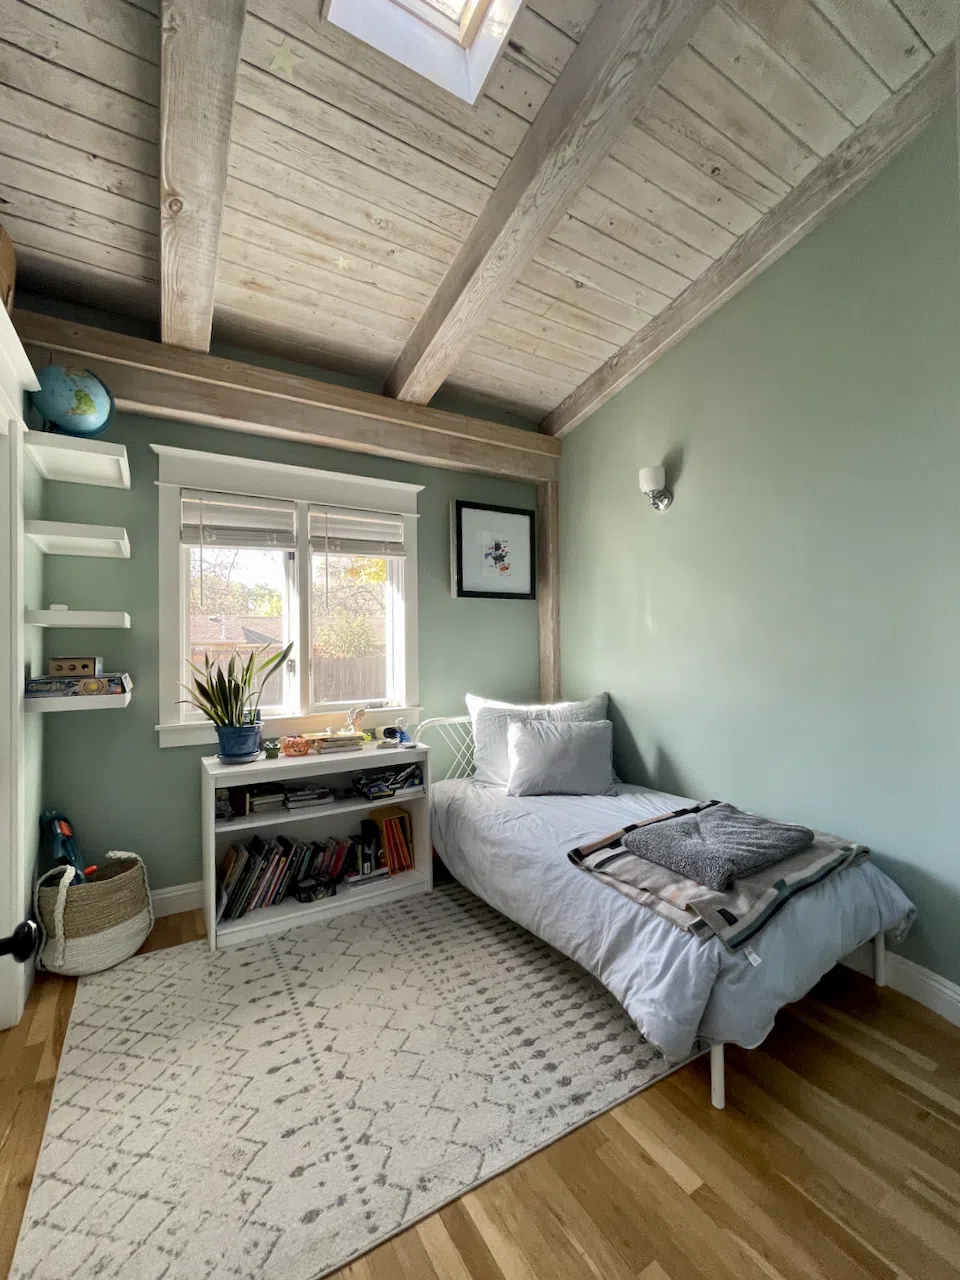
[541,46,954,436]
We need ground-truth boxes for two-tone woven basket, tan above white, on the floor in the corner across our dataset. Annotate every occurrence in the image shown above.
[33,852,154,977]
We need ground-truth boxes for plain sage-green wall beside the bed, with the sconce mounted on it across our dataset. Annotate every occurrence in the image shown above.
[561,111,960,982]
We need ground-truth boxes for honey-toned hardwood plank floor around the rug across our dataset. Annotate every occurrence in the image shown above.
[0,913,960,1280]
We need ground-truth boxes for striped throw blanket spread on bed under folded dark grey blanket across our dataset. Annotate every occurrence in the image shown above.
[567,809,870,951]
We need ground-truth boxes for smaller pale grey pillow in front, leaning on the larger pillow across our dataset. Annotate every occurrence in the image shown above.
[507,717,613,796]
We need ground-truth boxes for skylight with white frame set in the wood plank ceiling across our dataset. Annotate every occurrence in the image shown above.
[321,0,524,104]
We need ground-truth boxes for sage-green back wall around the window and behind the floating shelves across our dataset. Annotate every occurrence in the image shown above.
[32,320,539,888]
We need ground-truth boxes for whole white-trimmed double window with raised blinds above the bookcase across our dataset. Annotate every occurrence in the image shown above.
[154,445,420,746]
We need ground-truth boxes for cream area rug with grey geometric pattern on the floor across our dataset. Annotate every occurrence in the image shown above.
[12,884,668,1280]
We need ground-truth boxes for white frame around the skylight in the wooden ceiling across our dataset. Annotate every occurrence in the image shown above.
[321,0,524,106]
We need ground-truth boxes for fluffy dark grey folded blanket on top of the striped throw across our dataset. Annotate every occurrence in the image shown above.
[623,800,814,892]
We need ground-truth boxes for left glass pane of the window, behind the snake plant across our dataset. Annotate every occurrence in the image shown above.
[188,547,289,709]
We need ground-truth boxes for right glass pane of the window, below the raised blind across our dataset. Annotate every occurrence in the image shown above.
[311,554,390,707]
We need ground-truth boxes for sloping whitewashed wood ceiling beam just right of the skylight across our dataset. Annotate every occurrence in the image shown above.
[385,0,712,404]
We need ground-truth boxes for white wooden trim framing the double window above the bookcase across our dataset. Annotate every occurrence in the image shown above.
[150,444,424,746]
